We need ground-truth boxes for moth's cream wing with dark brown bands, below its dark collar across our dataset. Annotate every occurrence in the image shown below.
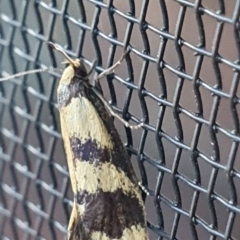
[60,96,148,240]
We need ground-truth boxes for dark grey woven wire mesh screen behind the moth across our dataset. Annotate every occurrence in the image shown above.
[0,0,240,240]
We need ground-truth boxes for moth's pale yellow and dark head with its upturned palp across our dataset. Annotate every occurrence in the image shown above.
[47,42,89,84]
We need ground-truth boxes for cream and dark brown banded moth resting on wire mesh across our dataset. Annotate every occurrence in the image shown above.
[0,42,149,240]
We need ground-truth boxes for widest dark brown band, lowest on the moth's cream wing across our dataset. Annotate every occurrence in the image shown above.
[76,189,146,240]
